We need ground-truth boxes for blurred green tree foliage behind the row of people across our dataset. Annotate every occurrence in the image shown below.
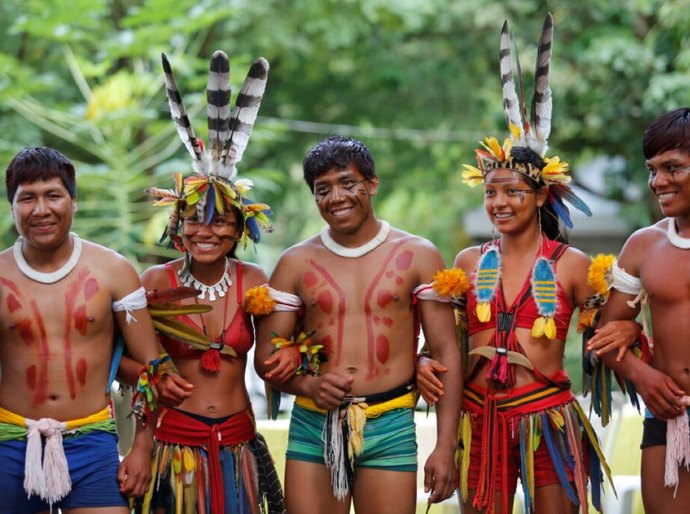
[0,0,690,271]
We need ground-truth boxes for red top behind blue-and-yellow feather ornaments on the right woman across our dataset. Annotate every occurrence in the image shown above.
[467,238,574,341]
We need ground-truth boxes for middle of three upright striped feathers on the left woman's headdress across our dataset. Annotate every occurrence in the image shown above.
[206,50,231,161]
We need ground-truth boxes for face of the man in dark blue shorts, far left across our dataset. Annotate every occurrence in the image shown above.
[12,177,77,250]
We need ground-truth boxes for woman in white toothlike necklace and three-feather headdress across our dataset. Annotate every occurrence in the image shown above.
[132,51,285,514]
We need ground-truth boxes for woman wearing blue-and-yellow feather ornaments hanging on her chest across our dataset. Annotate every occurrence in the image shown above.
[418,14,638,513]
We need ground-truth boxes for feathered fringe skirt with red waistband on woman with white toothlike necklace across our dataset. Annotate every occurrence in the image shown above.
[136,409,285,514]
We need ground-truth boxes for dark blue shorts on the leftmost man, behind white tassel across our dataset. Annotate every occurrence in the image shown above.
[0,430,128,514]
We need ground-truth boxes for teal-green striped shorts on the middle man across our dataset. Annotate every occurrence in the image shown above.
[287,405,417,472]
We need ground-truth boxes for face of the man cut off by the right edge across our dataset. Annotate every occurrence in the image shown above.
[646,149,690,217]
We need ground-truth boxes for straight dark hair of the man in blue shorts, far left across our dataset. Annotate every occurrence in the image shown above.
[5,146,77,203]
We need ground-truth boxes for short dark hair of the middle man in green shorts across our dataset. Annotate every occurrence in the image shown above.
[302,136,376,193]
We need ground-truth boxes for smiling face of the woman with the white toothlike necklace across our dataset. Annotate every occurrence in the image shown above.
[182,210,241,264]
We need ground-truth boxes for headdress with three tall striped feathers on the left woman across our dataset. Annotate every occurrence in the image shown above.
[147,50,271,249]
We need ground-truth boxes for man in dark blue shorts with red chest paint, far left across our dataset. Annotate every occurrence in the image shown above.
[0,147,163,514]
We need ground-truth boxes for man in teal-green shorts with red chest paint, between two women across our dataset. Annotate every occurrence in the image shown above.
[255,136,462,514]
